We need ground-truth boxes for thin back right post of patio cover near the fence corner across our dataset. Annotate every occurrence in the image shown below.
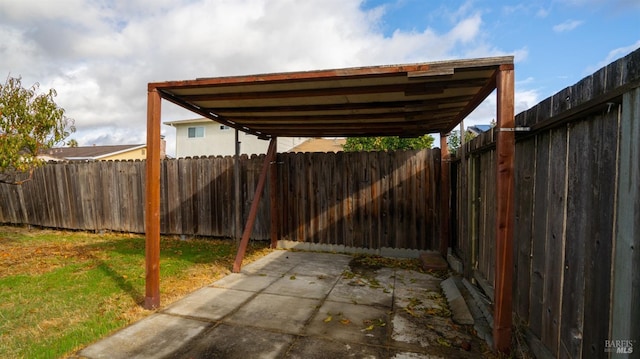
[440,133,451,258]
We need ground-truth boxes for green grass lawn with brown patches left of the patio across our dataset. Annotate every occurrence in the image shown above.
[0,226,268,358]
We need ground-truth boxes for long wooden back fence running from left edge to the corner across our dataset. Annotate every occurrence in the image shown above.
[0,149,440,249]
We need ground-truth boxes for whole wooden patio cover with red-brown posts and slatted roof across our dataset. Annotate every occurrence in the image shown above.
[145,56,515,351]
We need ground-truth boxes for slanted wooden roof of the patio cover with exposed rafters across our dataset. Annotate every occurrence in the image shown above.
[149,56,513,138]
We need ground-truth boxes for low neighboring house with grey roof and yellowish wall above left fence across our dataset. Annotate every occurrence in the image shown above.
[38,140,165,161]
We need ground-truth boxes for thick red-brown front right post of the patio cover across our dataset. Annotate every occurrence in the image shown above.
[493,65,515,353]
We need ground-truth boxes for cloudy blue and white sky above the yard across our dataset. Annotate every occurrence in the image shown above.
[0,0,640,153]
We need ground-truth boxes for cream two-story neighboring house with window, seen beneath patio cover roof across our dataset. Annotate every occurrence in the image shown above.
[164,118,306,157]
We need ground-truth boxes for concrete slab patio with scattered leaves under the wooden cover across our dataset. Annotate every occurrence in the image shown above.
[78,250,491,359]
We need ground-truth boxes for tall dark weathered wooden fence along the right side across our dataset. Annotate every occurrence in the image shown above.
[452,50,640,358]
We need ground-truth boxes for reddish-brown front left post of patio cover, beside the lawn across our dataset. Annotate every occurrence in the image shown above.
[144,88,162,309]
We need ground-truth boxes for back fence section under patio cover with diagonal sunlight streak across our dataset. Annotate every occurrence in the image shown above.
[279,151,439,249]
